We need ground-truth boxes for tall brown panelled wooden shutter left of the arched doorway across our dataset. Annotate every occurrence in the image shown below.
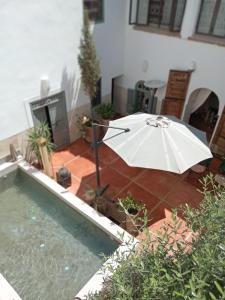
[161,70,191,118]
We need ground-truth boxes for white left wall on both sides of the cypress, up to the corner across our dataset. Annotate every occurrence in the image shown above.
[0,0,125,140]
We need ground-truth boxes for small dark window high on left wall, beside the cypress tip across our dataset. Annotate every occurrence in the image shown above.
[84,0,104,22]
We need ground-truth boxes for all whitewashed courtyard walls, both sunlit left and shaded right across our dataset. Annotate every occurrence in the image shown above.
[0,0,225,148]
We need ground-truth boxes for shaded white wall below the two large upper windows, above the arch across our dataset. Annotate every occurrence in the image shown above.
[120,0,225,113]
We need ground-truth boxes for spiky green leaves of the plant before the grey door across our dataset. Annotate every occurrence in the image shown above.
[28,122,54,163]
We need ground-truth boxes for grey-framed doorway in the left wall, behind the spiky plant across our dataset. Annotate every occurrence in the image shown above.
[30,92,70,149]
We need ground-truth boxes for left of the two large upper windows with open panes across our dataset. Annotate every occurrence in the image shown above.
[130,0,186,31]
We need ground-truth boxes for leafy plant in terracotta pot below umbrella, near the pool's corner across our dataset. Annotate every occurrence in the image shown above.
[119,193,144,235]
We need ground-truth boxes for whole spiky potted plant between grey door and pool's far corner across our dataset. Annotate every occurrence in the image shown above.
[26,122,54,168]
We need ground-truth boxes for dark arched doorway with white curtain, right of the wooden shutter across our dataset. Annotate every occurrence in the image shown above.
[189,89,219,141]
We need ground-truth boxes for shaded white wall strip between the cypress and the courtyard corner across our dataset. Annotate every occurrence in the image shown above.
[93,0,127,95]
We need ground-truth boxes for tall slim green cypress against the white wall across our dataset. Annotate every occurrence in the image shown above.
[78,10,100,99]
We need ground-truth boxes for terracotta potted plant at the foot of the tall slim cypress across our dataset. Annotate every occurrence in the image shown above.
[77,115,101,143]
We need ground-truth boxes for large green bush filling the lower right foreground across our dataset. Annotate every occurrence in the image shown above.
[88,176,225,300]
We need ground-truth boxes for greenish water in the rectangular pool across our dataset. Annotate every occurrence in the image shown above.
[0,170,119,300]
